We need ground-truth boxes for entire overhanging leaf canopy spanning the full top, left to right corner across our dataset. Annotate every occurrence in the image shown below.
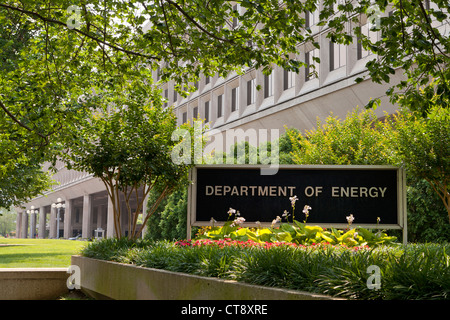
[0,0,450,209]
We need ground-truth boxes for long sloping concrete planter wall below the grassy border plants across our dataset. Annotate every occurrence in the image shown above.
[72,256,338,300]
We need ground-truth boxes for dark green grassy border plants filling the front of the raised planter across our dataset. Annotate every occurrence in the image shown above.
[82,239,450,300]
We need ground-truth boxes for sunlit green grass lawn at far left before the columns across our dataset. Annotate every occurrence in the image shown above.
[0,238,87,268]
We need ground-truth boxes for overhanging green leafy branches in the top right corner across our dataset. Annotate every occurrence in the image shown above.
[319,0,450,116]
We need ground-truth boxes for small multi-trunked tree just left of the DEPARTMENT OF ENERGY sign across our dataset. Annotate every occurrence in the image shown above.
[58,82,198,239]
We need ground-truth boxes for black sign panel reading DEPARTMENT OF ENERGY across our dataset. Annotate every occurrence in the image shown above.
[190,165,403,225]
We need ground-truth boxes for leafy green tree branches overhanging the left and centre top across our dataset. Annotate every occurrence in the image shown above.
[0,0,316,211]
